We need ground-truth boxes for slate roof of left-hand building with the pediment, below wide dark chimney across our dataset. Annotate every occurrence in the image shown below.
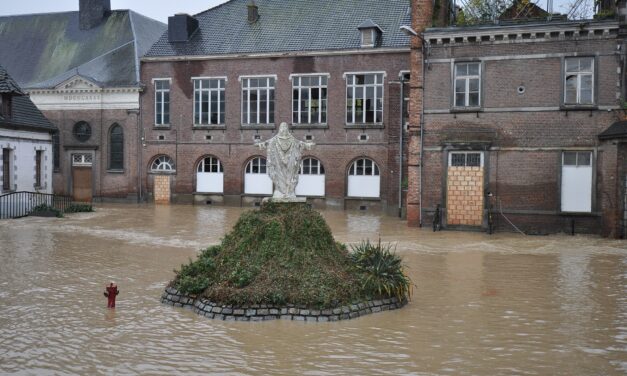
[0,10,166,89]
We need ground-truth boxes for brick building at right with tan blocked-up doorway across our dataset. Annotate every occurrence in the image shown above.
[408,1,627,236]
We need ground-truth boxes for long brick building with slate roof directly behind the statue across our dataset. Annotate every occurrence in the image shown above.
[141,0,410,213]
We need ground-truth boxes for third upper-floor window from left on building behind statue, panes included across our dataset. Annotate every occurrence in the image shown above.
[242,77,275,124]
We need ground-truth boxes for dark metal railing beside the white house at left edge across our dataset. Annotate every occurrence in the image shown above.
[0,191,72,219]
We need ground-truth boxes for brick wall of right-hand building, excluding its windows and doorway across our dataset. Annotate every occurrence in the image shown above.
[408,14,625,237]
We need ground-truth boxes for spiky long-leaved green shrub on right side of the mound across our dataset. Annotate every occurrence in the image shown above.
[351,239,412,300]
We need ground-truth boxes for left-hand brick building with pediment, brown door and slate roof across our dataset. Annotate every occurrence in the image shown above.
[0,0,166,201]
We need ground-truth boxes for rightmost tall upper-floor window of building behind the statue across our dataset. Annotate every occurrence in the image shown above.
[346,73,385,124]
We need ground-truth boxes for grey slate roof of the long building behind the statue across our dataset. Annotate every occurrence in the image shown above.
[146,0,411,57]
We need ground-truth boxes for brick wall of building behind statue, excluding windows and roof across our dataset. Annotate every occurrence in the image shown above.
[141,49,409,213]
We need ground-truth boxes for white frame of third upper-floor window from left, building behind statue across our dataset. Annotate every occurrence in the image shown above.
[238,74,277,128]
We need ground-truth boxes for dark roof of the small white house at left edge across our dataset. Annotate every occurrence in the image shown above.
[0,65,57,132]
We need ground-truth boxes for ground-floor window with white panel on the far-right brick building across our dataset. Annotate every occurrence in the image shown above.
[561,151,593,213]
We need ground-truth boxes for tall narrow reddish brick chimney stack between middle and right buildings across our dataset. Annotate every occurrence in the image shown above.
[407,0,433,227]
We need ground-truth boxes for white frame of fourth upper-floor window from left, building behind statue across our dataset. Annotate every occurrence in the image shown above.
[289,73,331,127]
